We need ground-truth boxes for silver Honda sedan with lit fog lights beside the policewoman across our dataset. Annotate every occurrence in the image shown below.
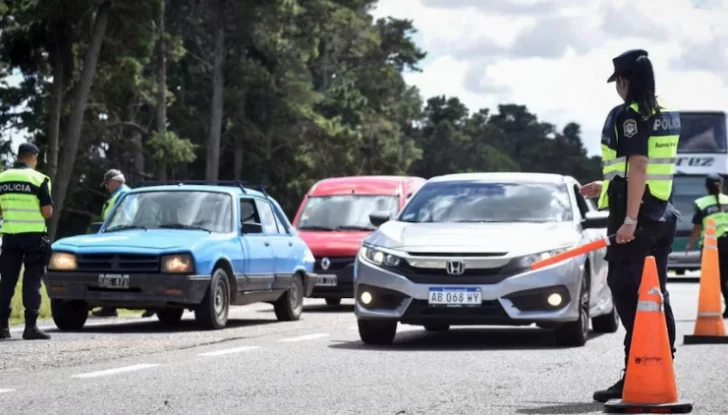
[354,173,619,346]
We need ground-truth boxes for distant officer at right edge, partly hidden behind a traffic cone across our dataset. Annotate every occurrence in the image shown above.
[685,174,728,318]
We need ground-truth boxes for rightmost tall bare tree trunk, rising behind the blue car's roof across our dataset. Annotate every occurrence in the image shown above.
[205,0,226,180]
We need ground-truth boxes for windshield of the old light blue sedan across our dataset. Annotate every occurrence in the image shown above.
[104,191,233,233]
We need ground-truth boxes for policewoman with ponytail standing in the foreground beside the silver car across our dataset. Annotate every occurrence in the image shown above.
[581,50,680,402]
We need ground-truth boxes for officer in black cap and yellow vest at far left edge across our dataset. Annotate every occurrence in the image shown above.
[0,143,53,340]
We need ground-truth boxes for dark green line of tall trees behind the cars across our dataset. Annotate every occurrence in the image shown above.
[0,0,600,237]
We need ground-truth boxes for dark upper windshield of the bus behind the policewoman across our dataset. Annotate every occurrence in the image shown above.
[677,112,727,153]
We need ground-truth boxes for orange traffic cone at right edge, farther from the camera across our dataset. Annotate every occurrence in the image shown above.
[683,218,728,344]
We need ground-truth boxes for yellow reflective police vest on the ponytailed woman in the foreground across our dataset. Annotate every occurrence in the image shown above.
[598,99,680,210]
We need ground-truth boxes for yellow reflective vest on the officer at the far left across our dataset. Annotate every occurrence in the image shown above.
[0,168,51,234]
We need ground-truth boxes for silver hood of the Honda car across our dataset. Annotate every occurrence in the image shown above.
[366,221,580,255]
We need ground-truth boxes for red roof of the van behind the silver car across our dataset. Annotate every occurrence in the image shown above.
[308,176,425,196]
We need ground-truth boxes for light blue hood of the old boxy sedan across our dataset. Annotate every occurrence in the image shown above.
[53,229,220,251]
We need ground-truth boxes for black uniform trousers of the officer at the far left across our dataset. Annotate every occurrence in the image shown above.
[0,233,48,324]
